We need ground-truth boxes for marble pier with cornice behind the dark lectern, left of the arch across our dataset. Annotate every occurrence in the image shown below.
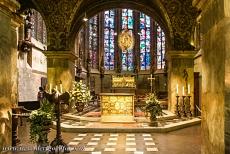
[45,51,77,91]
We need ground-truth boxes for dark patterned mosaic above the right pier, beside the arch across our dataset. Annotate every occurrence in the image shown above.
[161,0,199,50]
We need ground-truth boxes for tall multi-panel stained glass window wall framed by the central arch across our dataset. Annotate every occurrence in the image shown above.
[84,9,165,72]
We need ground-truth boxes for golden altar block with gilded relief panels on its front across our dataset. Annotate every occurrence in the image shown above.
[100,93,135,122]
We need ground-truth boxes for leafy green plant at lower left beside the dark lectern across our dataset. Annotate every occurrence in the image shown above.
[29,99,54,142]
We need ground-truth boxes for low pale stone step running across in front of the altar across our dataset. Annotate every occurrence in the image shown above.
[53,118,201,133]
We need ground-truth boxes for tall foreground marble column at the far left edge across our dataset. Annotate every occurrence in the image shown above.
[0,0,23,150]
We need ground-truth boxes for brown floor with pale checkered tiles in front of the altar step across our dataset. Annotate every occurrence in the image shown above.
[6,119,201,154]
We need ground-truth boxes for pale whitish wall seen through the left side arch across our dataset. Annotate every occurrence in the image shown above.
[18,40,47,102]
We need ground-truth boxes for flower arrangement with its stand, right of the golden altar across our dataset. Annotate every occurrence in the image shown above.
[144,93,162,126]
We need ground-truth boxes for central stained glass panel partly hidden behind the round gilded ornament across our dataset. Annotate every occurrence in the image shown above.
[121,9,134,71]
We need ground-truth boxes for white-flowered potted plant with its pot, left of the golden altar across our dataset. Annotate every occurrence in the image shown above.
[70,80,91,112]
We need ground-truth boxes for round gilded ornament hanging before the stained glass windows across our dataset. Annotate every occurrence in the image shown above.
[118,29,134,51]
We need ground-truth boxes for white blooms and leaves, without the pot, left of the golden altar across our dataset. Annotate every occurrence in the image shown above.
[70,81,92,103]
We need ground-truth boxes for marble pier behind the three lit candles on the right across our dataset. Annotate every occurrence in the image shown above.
[167,51,195,114]
